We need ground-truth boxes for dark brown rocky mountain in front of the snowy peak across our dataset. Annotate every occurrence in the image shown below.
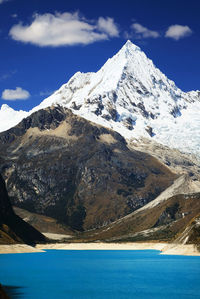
[0,107,176,230]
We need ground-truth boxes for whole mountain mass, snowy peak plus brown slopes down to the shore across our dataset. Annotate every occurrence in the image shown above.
[0,41,200,244]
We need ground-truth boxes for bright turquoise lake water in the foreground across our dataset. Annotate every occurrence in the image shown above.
[0,250,200,299]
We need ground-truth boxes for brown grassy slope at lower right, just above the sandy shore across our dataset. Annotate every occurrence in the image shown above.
[80,193,200,245]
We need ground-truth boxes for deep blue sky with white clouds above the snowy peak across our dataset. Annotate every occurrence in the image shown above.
[0,0,200,110]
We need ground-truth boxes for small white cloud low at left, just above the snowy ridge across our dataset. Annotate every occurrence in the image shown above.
[1,87,30,101]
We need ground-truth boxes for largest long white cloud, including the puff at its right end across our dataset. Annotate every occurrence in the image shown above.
[9,12,118,47]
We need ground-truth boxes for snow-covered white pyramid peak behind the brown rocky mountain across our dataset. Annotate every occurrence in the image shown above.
[0,41,200,154]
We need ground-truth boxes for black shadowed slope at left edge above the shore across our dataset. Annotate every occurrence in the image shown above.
[0,175,45,245]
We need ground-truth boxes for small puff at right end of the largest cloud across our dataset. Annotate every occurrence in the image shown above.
[97,17,119,37]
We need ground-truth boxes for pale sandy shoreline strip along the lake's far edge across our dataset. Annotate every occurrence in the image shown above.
[0,242,200,256]
